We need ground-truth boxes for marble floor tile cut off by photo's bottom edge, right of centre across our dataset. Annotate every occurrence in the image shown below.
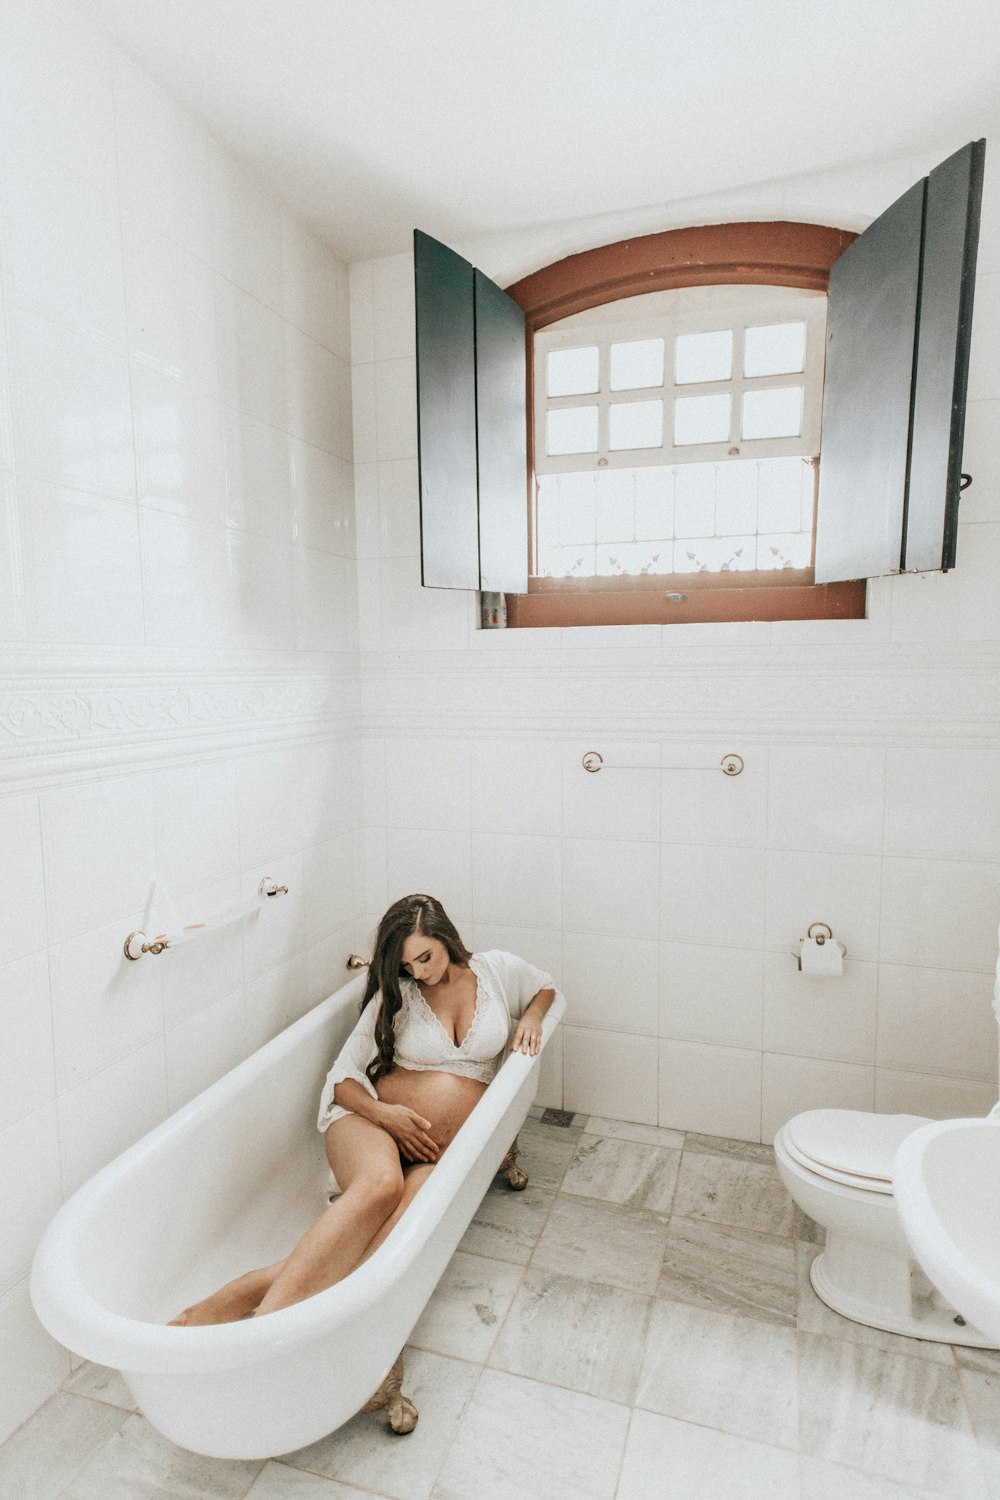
[616,1412,803,1500]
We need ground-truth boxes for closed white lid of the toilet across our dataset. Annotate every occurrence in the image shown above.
[784,1110,928,1193]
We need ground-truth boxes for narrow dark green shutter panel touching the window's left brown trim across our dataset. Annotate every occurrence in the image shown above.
[475,270,528,594]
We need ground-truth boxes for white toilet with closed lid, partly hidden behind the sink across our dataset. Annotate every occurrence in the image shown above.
[774,1110,996,1349]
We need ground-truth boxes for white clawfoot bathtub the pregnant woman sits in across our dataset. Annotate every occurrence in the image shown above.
[31,975,565,1458]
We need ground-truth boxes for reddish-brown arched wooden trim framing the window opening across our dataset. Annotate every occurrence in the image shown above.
[507,222,867,627]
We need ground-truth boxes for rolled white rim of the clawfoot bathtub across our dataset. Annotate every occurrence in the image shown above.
[30,975,565,1374]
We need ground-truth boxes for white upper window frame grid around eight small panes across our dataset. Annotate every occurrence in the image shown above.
[534,285,826,474]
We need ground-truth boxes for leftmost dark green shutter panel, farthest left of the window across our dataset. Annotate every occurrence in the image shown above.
[414,230,480,588]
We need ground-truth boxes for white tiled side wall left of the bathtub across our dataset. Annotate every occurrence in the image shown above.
[0,0,359,1439]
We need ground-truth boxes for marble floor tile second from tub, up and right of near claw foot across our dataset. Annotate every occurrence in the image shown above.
[489,1268,652,1401]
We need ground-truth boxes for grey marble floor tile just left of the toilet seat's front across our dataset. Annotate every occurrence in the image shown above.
[673,1136,795,1235]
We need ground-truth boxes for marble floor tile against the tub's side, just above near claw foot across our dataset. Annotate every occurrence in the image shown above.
[409,1250,523,1364]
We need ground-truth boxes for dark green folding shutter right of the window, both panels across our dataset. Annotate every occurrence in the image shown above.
[816,141,985,584]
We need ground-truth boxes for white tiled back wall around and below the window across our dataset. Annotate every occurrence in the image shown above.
[351,132,1000,1140]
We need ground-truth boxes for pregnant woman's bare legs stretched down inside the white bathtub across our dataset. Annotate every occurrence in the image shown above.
[172,1115,403,1326]
